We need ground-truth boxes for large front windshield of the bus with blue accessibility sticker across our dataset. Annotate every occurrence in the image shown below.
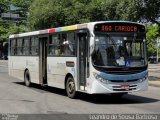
[92,34,147,67]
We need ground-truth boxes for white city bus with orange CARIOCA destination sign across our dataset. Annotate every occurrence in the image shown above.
[8,21,148,98]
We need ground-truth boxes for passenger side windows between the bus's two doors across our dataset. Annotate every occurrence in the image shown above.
[48,32,76,56]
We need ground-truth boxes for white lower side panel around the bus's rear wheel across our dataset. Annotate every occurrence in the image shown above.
[8,56,39,83]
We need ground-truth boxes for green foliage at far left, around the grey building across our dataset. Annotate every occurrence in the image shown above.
[0,0,32,41]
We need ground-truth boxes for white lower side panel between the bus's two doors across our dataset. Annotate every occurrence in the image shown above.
[47,57,77,89]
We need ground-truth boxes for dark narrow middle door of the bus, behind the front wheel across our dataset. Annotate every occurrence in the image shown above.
[39,37,48,85]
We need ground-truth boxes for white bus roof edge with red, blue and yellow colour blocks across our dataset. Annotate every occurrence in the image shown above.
[9,21,142,38]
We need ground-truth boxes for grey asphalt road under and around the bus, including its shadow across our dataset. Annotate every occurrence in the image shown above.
[0,63,160,114]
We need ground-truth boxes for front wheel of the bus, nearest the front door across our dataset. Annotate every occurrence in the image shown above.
[66,76,76,99]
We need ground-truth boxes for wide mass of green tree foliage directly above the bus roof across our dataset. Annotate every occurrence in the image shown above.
[29,0,160,29]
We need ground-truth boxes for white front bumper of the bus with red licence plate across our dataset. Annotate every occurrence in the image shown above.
[90,79,148,94]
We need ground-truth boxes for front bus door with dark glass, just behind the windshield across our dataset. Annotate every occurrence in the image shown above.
[77,32,88,90]
